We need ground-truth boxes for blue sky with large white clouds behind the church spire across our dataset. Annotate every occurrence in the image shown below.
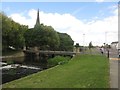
[2,0,118,45]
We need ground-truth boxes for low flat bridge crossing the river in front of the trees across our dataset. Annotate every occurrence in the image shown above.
[23,50,79,61]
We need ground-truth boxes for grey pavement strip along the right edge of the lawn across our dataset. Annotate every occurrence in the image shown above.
[109,49,120,90]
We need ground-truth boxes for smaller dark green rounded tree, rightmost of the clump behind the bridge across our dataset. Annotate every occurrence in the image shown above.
[58,32,74,51]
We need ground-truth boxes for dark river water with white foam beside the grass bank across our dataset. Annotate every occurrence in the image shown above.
[0,57,50,84]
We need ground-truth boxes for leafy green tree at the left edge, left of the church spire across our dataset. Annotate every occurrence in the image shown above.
[0,13,28,50]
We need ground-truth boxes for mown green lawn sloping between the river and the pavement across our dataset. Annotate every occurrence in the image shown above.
[3,55,109,88]
